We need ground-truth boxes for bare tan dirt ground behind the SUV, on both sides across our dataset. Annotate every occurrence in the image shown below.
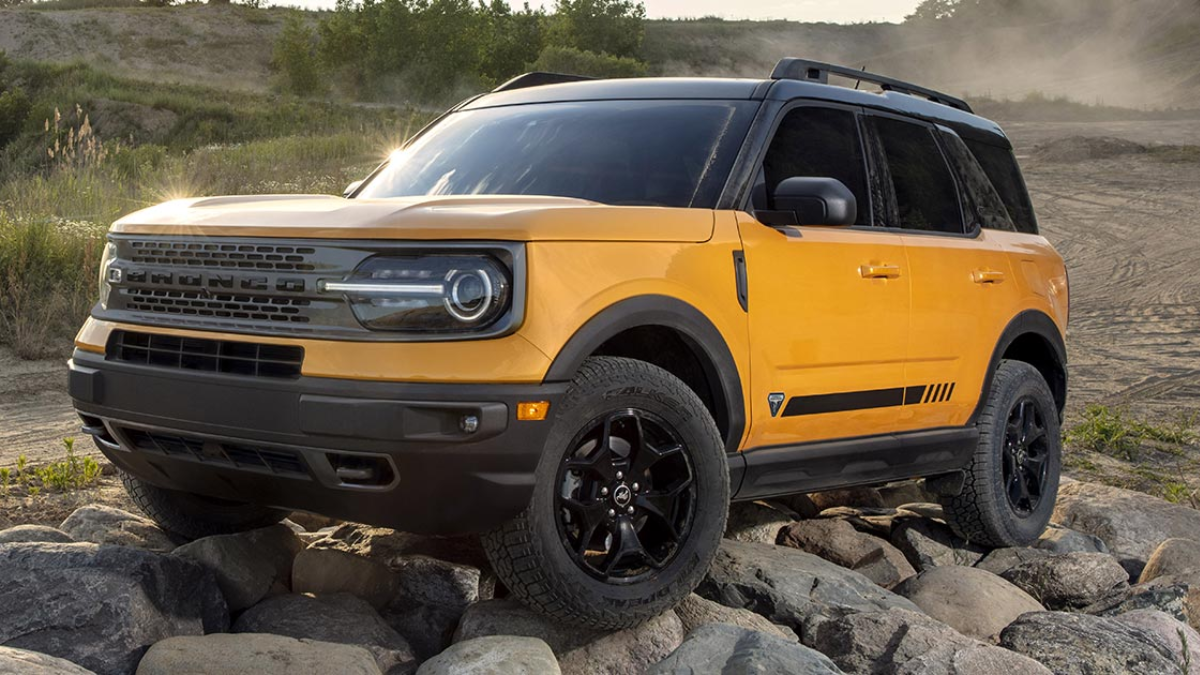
[0,120,1200,488]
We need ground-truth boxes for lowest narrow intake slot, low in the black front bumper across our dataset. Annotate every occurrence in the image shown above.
[121,428,310,478]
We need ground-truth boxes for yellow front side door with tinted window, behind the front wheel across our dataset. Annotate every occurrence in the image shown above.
[739,104,910,448]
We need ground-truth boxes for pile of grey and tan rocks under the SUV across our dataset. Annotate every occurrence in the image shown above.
[0,482,1200,675]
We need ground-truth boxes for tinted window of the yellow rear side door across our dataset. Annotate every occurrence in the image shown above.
[874,118,965,233]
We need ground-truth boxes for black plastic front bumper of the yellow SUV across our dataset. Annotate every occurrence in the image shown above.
[70,351,566,534]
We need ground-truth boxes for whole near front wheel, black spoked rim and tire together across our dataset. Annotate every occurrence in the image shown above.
[484,357,730,629]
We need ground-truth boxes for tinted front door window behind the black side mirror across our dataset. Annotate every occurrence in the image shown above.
[762,107,871,225]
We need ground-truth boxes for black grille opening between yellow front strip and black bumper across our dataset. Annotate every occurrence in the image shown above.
[106,330,304,378]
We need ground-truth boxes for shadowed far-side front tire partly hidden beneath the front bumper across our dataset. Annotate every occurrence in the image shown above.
[120,471,288,539]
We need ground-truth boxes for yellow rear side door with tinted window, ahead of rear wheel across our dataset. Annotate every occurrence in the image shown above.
[869,114,1016,430]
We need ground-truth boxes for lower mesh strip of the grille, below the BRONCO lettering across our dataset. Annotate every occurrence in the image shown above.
[121,288,312,323]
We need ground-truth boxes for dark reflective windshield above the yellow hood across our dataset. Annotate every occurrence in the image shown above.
[358,101,757,208]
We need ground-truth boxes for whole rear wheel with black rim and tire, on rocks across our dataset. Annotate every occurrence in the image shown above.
[942,360,1062,546]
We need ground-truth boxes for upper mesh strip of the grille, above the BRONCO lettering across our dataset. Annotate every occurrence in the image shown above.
[130,239,317,271]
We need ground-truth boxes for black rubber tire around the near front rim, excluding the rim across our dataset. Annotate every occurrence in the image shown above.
[482,357,730,631]
